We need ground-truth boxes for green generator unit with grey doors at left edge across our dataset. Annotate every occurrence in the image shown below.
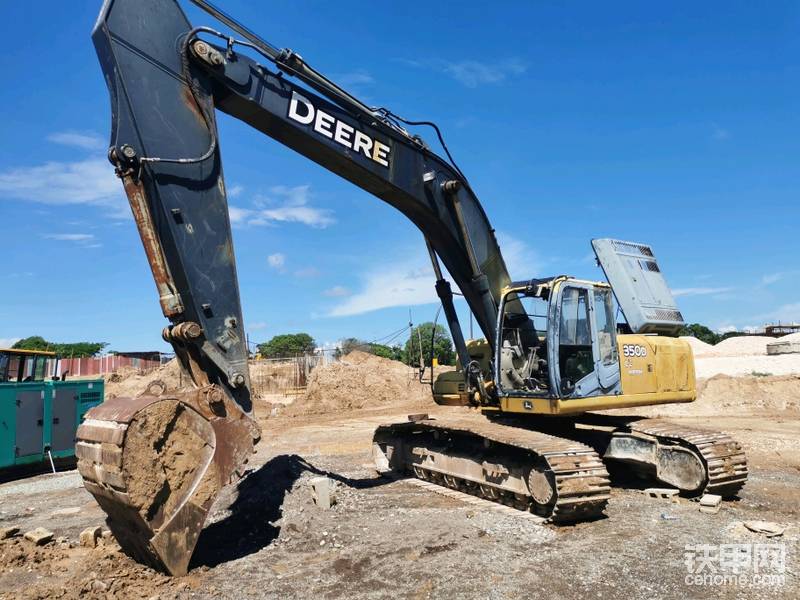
[0,349,104,472]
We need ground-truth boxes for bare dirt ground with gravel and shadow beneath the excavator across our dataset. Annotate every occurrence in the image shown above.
[0,366,800,600]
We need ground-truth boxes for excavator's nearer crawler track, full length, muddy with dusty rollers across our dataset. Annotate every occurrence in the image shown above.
[373,418,611,523]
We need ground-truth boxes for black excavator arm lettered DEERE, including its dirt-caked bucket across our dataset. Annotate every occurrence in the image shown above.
[77,0,532,574]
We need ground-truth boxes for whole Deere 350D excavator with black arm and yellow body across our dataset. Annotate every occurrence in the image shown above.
[76,0,747,574]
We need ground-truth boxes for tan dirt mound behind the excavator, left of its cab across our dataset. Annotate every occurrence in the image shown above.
[285,350,433,415]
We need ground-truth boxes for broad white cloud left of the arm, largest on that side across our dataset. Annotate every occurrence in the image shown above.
[0,158,129,217]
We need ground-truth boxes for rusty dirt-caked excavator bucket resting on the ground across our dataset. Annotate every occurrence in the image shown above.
[76,386,259,575]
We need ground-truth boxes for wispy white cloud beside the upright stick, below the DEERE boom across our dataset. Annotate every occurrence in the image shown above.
[229,185,336,229]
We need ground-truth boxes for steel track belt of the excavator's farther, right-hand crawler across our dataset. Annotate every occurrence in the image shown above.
[628,419,748,498]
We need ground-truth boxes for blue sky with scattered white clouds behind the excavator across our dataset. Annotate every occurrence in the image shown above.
[0,0,800,350]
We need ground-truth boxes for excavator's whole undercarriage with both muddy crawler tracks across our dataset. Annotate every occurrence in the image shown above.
[373,414,747,523]
